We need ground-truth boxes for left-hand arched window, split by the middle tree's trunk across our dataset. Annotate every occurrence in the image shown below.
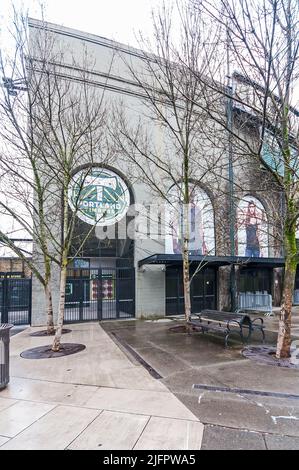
[165,183,215,256]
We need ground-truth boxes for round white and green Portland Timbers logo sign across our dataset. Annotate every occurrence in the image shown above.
[68,168,130,226]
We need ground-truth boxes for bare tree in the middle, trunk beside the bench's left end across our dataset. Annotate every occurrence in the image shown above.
[111,2,224,321]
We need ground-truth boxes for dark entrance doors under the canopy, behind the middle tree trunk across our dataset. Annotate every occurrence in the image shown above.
[166,268,216,315]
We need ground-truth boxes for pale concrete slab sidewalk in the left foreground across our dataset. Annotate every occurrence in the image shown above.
[0,323,203,450]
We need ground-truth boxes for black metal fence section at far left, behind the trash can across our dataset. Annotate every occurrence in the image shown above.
[0,277,32,325]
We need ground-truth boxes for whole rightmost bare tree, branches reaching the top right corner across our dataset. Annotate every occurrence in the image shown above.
[189,0,299,358]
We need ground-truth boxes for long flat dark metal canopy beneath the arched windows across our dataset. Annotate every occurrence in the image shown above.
[138,253,284,268]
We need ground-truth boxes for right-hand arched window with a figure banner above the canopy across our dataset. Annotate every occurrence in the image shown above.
[236,195,269,258]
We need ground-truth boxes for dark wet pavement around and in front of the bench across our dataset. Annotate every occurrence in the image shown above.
[101,314,299,449]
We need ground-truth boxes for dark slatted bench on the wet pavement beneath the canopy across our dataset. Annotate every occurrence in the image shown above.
[188,310,265,347]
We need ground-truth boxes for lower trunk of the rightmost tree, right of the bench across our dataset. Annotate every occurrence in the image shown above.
[276,227,297,359]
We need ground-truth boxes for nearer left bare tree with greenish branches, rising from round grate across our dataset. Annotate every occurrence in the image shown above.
[1,11,109,351]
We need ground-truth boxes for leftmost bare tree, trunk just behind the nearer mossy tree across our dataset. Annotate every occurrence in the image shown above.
[0,11,54,334]
